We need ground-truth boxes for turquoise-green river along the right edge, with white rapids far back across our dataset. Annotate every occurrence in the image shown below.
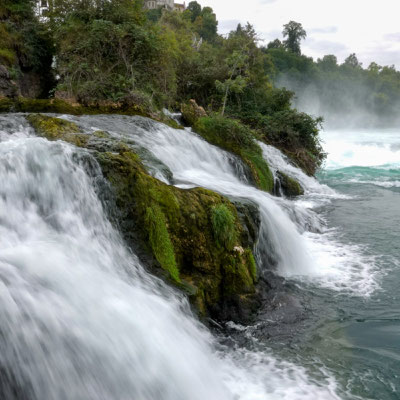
[304,130,400,400]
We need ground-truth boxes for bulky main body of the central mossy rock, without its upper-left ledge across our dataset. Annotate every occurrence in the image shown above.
[97,150,256,318]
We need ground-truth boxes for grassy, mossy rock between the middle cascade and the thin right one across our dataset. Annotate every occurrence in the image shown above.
[194,116,274,193]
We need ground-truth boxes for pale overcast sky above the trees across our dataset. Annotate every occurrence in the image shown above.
[198,0,400,69]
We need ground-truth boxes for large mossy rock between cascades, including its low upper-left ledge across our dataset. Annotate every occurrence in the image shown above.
[27,114,258,320]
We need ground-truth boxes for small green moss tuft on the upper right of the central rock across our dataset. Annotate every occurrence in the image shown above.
[211,204,237,250]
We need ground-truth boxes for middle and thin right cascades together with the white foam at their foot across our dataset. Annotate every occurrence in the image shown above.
[70,116,376,294]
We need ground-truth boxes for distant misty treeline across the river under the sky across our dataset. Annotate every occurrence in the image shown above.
[263,36,400,127]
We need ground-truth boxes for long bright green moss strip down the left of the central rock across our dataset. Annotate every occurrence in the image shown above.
[145,205,180,282]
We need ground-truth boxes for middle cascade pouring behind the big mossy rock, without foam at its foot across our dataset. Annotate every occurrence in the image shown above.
[74,117,313,275]
